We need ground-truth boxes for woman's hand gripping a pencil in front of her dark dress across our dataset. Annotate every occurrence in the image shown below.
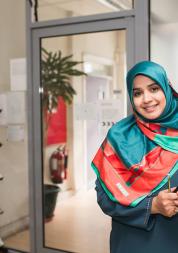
[151,187,178,217]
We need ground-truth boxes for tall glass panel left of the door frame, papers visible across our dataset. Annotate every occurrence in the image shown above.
[0,0,30,252]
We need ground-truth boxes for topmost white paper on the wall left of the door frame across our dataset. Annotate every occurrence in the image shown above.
[10,58,27,91]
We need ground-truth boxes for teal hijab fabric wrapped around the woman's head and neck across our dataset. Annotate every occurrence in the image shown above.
[127,61,178,129]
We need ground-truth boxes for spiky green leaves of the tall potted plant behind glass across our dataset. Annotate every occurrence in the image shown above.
[41,48,86,112]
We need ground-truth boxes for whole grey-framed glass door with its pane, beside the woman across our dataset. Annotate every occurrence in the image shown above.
[30,14,134,253]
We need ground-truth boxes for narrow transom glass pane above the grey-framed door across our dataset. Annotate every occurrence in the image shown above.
[33,0,133,21]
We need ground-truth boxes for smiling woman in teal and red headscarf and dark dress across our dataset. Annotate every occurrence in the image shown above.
[92,61,178,253]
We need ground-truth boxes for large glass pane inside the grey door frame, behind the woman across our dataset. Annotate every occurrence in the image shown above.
[41,30,127,253]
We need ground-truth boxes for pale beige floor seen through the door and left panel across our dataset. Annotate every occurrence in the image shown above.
[5,190,111,253]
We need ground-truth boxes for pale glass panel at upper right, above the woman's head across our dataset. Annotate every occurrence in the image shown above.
[151,0,178,90]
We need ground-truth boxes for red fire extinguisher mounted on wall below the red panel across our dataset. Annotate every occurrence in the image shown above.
[49,146,68,184]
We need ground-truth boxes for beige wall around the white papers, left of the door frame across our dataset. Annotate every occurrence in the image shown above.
[0,0,28,236]
